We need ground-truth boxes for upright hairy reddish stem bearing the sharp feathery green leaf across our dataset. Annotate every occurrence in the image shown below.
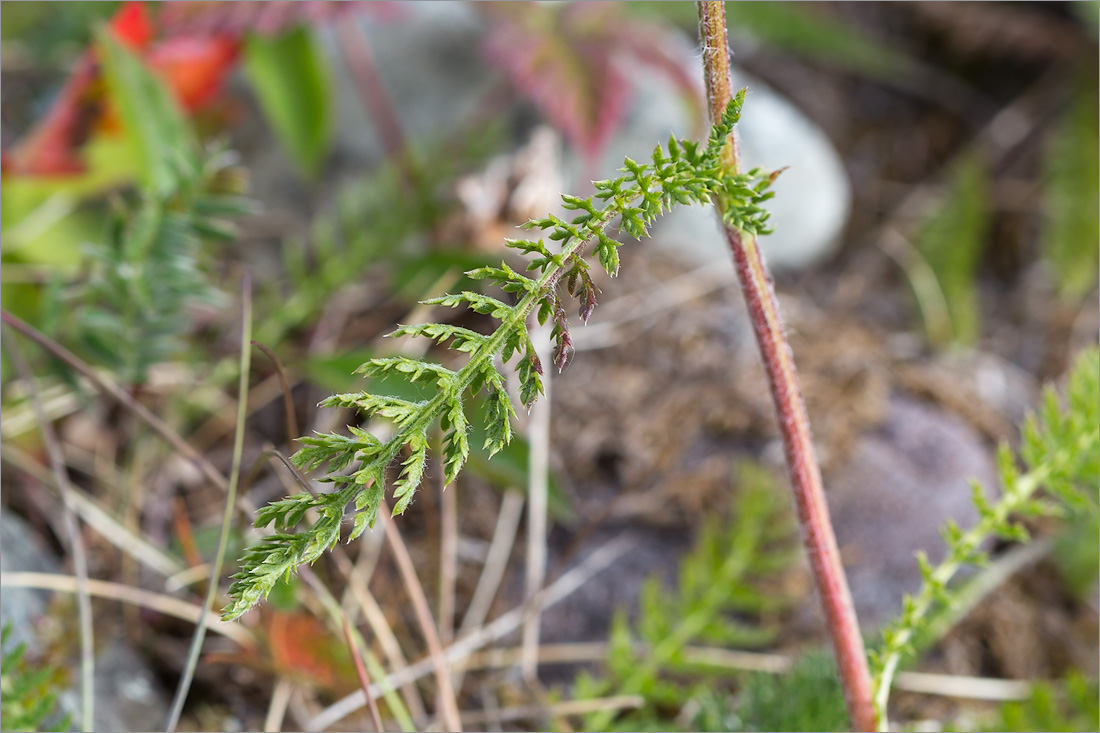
[696,1,877,731]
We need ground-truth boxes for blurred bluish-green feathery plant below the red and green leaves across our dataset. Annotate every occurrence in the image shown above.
[62,151,251,384]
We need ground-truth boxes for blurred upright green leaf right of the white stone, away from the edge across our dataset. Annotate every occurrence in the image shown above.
[915,156,990,347]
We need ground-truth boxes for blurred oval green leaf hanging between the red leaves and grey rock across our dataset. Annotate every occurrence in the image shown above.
[244,28,332,176]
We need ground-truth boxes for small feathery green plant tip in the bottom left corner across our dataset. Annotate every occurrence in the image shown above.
[0,623,70,731]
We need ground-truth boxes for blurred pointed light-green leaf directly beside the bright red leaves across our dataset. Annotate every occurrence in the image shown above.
[97,29,197,192]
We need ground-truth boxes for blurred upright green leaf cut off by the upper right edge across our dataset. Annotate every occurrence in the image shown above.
[1043,74,1100,299]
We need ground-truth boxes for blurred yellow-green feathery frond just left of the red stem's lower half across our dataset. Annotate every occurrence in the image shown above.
[575,463,796,731]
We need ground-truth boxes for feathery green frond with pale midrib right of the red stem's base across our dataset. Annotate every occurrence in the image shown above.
[871,349,1100,721]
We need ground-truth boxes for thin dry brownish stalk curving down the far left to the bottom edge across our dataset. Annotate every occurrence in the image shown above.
[3,331,96,731]
